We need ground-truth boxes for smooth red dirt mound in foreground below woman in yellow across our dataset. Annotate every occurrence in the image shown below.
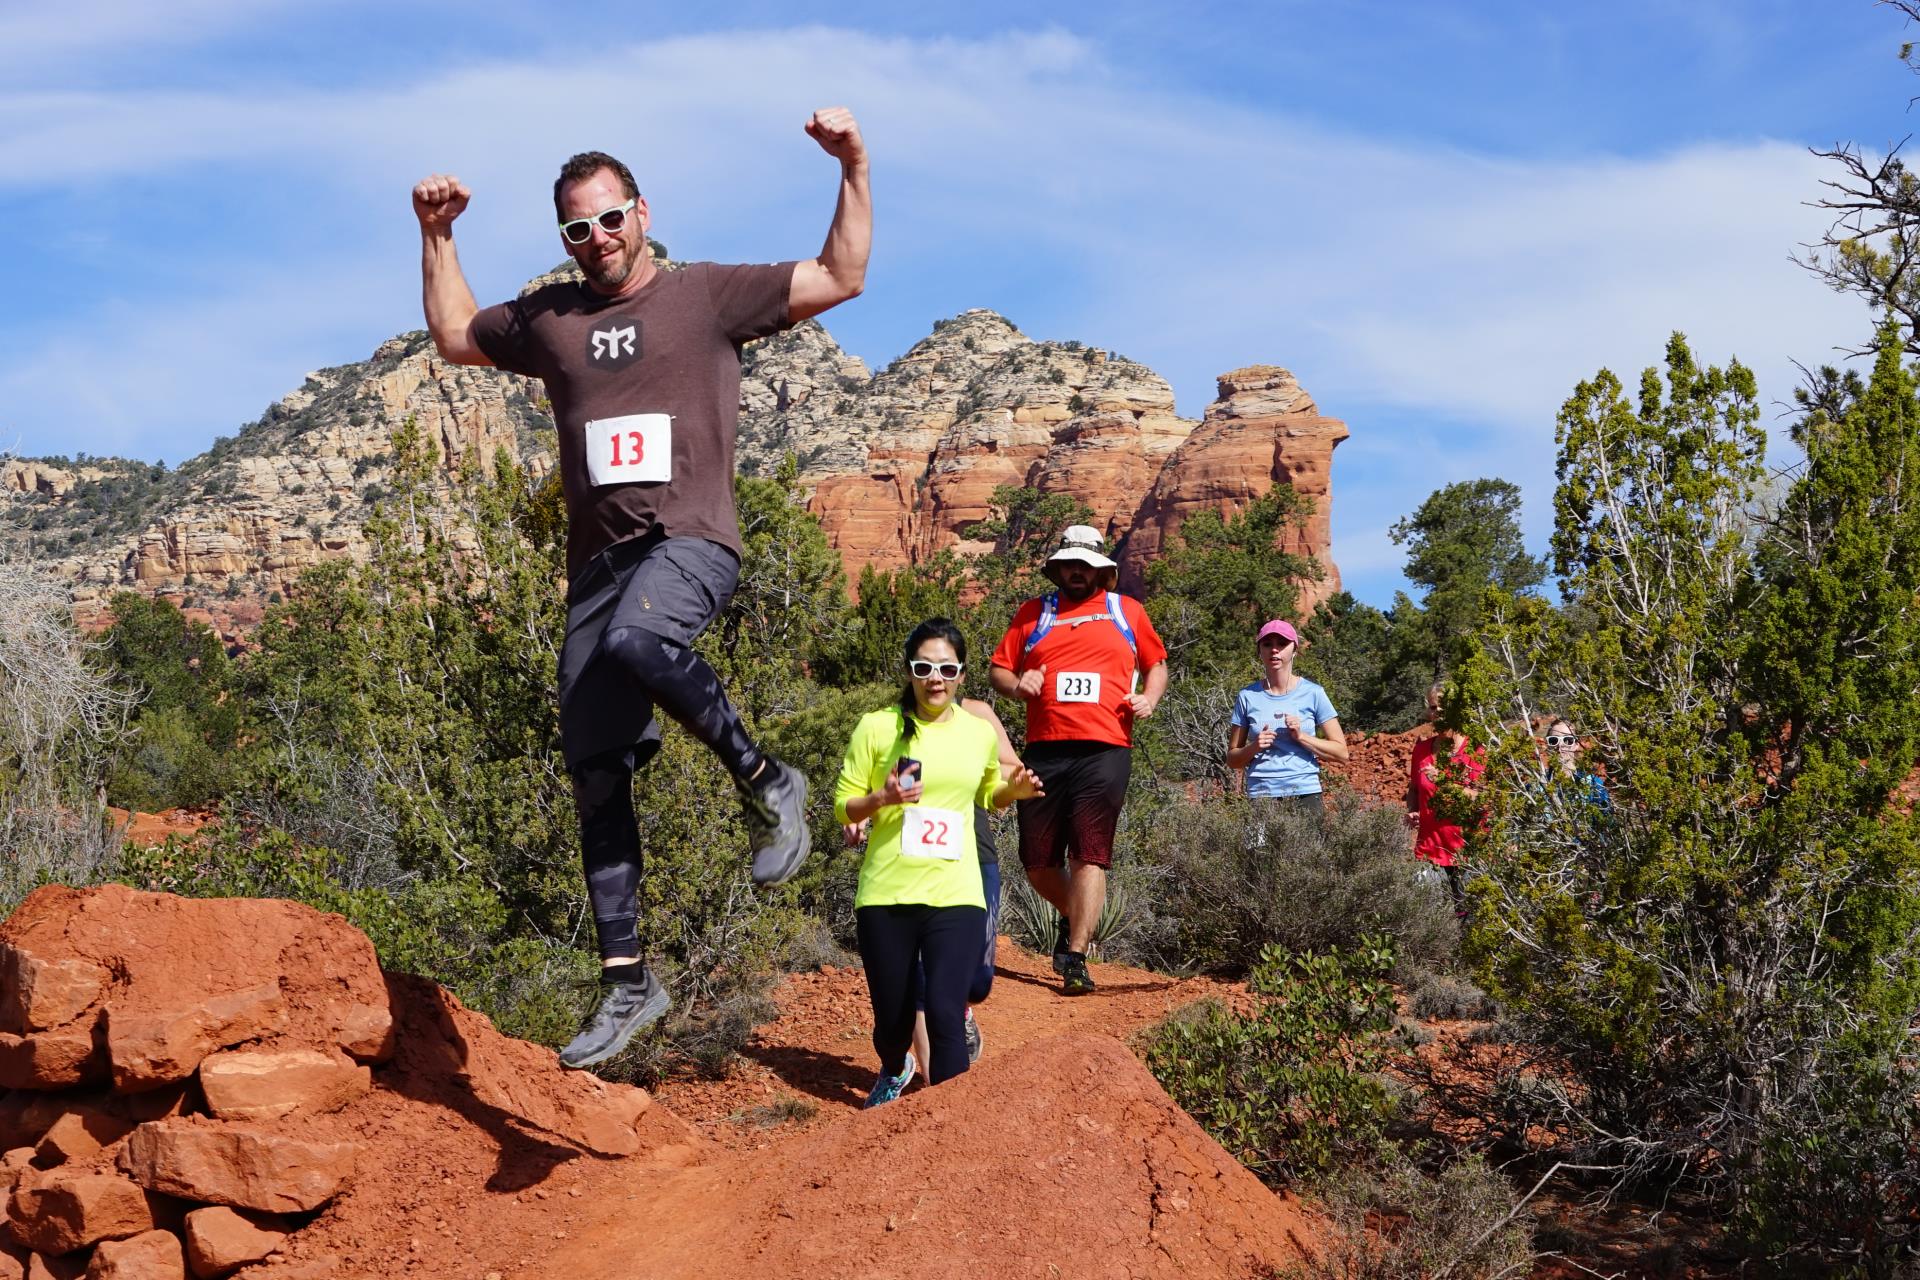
[537,1034,1315,1280]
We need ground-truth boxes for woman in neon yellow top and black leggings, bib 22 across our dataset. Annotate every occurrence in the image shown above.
[833,618,1041,1107]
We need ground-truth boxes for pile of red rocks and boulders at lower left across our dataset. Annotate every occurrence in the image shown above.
[0,887,683,1276]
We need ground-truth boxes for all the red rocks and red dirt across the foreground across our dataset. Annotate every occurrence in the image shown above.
[0,887,1319,1280]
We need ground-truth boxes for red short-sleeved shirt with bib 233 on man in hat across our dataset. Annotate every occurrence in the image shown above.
[993,591,1167,747]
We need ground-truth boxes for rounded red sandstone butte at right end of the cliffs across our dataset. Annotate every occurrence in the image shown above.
[1119,365,1348,618]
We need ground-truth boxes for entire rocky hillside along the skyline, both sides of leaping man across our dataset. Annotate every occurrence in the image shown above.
[0,268,1346,626]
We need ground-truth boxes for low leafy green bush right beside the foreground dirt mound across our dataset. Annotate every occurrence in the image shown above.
[1142,936,1394,1186]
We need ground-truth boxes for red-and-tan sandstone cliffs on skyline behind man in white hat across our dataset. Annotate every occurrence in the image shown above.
[808,345,1348,618]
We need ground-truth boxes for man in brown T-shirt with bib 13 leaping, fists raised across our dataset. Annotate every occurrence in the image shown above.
[413,107,874,1067]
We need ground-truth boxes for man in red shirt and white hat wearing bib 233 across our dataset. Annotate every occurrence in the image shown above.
[989,524,1167,996]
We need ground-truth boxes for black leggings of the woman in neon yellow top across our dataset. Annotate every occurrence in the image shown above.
[852,906,987,1084]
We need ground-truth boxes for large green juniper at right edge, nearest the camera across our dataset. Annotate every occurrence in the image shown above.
[1457,334,1920,1274]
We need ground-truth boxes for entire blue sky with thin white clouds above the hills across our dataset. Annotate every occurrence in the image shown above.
[0,0,1920,604]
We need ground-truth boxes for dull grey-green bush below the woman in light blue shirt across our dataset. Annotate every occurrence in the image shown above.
[1146,793,1457,981]
